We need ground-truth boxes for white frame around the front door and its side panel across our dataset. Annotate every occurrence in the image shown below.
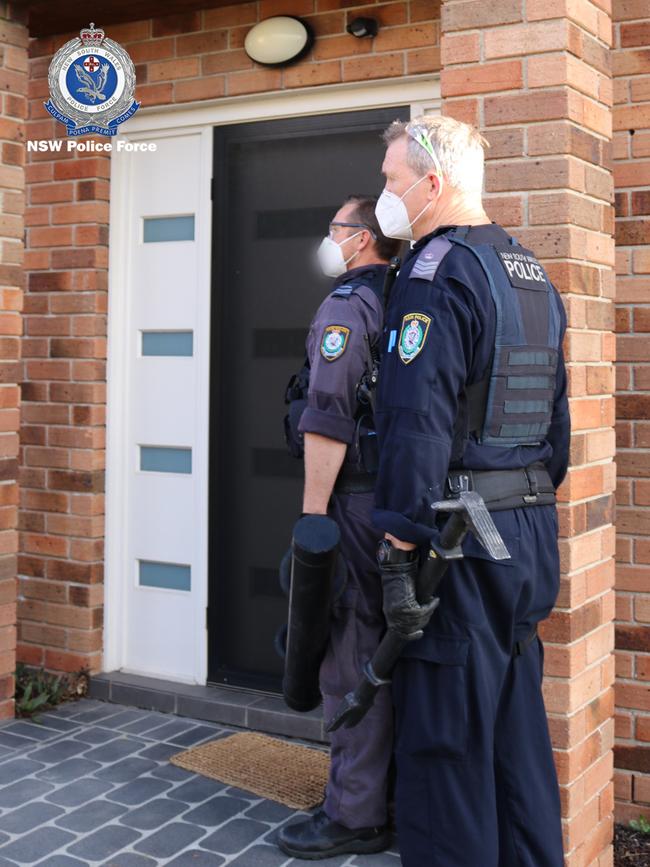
[103,76,440,684]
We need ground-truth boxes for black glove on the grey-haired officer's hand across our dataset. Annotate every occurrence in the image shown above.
[378,542,438,641]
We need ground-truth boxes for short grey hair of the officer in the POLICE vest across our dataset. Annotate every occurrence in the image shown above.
[383,115,490,196]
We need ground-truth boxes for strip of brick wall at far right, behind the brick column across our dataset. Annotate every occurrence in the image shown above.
[613,0,650,822]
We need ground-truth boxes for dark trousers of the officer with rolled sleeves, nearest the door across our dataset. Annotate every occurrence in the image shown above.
[320,493,393,828]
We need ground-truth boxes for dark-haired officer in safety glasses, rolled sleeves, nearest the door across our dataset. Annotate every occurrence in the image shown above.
[278,196,401,860]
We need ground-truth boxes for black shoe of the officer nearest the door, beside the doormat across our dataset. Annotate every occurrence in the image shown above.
[278,810,390,861]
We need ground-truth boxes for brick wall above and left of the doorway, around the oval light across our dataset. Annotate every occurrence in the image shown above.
[18,0,440,672]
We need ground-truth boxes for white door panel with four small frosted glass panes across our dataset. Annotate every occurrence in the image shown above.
[107,132,210,683]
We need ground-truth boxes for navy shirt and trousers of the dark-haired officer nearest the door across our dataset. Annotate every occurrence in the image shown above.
[294,265,393,829]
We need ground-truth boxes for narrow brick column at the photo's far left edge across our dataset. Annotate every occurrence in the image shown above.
[0,2,27,718]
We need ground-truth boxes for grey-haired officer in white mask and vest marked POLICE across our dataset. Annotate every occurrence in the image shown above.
[373,117,570,867]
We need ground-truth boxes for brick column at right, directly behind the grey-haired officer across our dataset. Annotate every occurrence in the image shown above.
[442,0,615,867]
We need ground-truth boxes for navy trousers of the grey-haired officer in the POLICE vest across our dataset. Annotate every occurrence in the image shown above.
[393,506,564,867]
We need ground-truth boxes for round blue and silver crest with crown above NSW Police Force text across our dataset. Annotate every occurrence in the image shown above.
[44,23,140,135]
